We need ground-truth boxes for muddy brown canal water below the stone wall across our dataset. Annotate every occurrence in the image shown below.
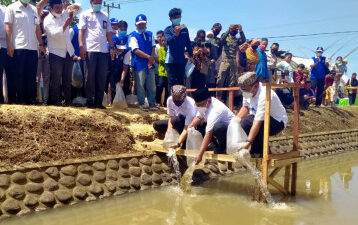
[0,152,358,225]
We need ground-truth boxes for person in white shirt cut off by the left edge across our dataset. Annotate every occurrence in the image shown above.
[0,5,7,104]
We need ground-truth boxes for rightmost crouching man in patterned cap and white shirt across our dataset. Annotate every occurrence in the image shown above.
[236,72,288,157]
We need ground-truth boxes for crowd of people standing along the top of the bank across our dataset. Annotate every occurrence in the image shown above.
[0,0,357,110]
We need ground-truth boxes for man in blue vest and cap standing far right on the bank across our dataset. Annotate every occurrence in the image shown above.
[310,47,327,107]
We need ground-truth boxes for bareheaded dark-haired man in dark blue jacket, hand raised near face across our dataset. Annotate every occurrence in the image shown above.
[164,8,193,90]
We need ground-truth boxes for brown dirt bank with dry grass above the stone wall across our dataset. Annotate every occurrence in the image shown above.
[0,105,358,166]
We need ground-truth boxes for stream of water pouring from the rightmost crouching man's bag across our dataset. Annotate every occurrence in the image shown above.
[233,149,275,207]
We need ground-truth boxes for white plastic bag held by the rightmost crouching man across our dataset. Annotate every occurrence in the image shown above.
[226,117,249,154]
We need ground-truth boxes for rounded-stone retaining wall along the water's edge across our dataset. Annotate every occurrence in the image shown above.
[0,130,358,220]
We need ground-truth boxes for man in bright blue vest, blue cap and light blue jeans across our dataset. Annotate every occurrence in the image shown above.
[129,14,158,110]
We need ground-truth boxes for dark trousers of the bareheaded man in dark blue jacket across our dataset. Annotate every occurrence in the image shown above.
[165,63,185,93]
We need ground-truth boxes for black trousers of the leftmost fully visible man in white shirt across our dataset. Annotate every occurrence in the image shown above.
[6,49,38,104]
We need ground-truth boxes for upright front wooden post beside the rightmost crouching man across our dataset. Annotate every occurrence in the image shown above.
[262,83,271,188]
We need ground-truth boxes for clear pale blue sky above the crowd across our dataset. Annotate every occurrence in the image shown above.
[76,0,358,77]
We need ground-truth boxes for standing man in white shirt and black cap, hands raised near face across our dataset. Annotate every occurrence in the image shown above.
[44,0,77,105]
